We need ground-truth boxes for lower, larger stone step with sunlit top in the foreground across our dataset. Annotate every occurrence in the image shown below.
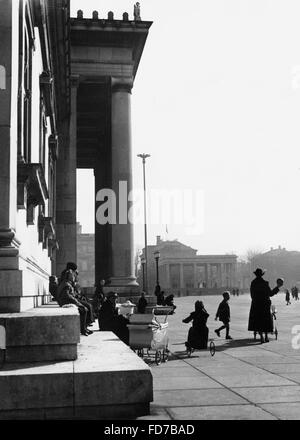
[0,331,153,420]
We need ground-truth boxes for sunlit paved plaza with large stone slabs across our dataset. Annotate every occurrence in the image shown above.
[140,293,300,420]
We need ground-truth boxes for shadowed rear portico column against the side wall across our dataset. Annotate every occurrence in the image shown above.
[56,76,79,276]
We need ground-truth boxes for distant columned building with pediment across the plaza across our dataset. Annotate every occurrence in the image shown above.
[138,236,237,294]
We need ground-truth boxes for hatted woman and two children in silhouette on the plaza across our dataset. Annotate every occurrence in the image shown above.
[182,268,283,349]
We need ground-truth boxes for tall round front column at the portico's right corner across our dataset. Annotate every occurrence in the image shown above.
[110,78,138,293]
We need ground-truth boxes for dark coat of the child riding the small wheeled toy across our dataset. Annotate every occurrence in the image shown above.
[182,309,209,349]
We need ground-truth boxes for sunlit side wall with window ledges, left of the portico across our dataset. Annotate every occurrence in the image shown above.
[0,0,70,312]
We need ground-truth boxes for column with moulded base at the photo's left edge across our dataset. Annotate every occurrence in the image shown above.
[0,1,22,312]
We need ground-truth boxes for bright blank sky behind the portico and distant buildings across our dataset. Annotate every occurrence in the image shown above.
[71,0,300,255]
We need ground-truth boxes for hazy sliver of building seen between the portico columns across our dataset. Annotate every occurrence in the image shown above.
[77,223,95,287]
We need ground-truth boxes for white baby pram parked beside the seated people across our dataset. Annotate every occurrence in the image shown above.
[127,311,169,365]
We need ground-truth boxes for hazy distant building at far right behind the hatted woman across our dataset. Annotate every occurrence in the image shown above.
[251,246,300,288]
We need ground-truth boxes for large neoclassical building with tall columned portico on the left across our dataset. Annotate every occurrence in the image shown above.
[0,0,152,313]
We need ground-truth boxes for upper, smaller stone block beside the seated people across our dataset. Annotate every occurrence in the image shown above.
[0,304,80,362]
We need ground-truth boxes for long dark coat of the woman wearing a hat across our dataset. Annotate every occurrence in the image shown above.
[248,277,279,333]
